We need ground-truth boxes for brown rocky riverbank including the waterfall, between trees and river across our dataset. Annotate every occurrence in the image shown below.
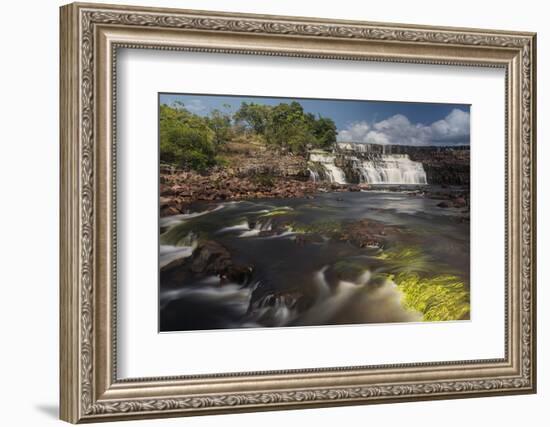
[159,142,469,217]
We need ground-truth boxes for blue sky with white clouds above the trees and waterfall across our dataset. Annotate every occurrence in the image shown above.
[159,93,470,146]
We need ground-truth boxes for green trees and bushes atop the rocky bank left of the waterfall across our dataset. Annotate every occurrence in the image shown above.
[159,101,336,172]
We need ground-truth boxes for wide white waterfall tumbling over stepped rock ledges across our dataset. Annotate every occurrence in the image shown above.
[309,143,427,185]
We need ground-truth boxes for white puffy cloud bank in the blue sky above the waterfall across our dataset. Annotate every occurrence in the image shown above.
[338,108,470,145]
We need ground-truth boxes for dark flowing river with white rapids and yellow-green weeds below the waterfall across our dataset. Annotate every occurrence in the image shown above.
[159,187,469,331]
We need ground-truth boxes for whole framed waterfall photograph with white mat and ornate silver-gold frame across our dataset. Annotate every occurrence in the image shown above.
[60,4,536,423]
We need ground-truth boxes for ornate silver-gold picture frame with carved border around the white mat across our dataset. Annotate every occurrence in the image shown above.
[60,3,536,423]
